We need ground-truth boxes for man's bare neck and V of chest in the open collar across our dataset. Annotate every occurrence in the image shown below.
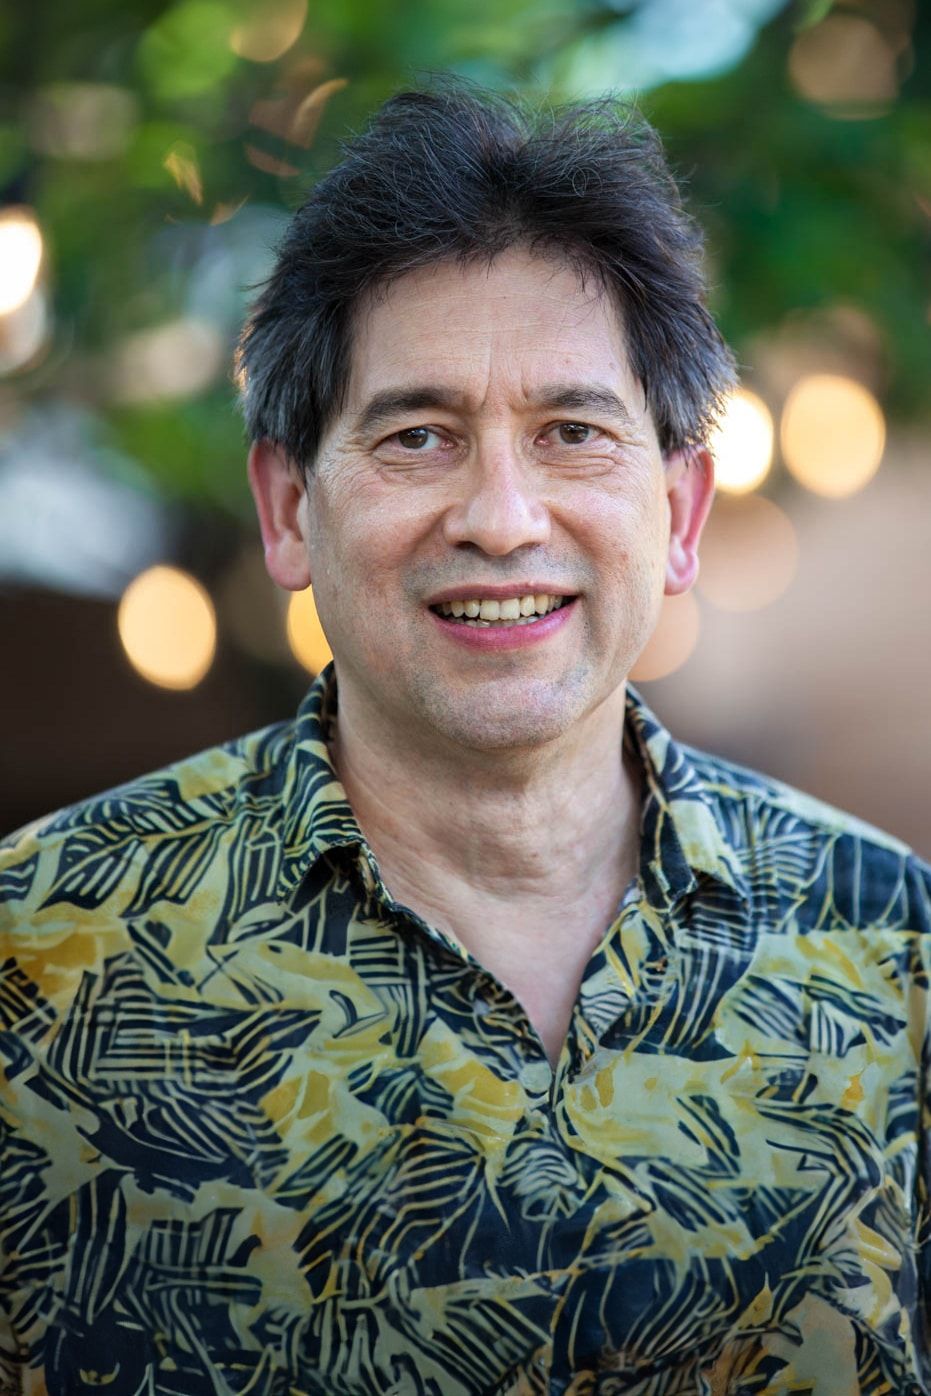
[334,687,639,1064]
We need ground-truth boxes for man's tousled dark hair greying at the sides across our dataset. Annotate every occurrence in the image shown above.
[239,82,734,466]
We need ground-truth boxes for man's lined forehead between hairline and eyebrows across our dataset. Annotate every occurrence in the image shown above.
[346,248,642,412]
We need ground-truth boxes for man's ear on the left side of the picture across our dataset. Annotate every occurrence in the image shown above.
[248,441,310,592]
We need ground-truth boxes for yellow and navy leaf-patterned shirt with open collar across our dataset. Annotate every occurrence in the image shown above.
[0,674,931,1396]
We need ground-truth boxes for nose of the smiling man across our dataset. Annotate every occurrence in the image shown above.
[444,443,550,557]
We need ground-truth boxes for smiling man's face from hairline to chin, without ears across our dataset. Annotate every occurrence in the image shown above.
[291,248,706,750]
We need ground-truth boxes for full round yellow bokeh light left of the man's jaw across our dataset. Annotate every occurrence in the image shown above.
[117,565,216,688]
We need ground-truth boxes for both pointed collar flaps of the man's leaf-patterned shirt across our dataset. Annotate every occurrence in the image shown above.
[278,664,750,903]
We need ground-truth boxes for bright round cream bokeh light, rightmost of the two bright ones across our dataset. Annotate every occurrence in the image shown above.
[780,373,886,498]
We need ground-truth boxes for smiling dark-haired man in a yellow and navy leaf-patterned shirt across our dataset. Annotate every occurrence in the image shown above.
[0,88,931,1396]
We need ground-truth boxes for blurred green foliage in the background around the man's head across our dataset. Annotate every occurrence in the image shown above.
[0,0,931,511]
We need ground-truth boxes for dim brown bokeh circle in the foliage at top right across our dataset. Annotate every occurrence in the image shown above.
[789,11,899,114]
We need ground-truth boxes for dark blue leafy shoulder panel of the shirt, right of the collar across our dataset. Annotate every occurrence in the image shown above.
[681,747,931,931]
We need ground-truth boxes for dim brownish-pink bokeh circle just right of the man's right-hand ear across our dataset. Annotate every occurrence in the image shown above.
[698,494,798,611]
